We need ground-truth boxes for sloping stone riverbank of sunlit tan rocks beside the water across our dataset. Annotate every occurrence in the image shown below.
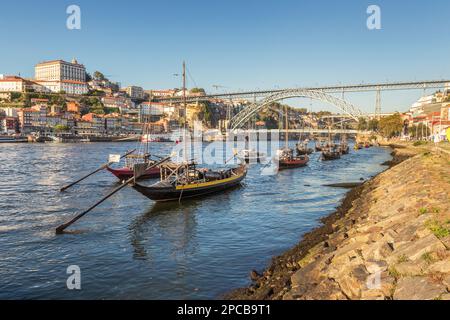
[226,145,450,300]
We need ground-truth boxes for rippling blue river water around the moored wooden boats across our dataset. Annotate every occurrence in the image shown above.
[0,143,390,299]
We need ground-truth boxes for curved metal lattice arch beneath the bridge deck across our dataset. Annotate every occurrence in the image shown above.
[230,89,363,130]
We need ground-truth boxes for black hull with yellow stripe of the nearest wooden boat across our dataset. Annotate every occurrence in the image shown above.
[133,169,247,202]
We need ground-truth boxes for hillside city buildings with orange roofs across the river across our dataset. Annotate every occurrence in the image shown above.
[0,59,450,139]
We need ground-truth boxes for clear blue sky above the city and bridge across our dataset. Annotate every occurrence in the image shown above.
[0,0,450,111]
